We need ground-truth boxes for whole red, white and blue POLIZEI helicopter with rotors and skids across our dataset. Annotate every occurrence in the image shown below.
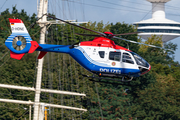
[5,15,169,82]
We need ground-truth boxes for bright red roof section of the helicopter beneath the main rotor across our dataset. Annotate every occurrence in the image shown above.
[80,37,130,51]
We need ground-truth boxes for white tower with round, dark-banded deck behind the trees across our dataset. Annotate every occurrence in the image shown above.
[134,0,180,43]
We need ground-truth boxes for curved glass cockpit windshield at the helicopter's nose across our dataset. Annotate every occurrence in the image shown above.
[131,52,149,68]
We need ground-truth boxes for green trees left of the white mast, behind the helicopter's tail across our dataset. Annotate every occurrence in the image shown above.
[0,6,40,120]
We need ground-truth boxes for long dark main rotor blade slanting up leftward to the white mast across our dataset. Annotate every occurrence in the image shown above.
[46,14,106,37]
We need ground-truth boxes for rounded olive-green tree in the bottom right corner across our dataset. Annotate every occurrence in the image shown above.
[132,75,180,120]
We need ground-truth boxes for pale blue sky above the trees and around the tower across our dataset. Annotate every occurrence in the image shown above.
[0,0,180,62]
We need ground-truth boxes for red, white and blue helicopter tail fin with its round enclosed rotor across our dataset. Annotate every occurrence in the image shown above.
[5,18,39,60]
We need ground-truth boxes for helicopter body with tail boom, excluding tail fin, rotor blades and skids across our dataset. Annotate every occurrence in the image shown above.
[37,37,151,77]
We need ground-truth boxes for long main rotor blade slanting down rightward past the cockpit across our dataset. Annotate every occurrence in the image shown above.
[113,36,173,51]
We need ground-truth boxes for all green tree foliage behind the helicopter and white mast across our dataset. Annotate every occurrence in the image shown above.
[0,7,180,120]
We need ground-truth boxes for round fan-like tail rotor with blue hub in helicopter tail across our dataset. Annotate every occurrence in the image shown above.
[12,36,26,51]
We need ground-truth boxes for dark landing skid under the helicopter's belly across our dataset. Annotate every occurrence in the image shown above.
[83,74,133,86]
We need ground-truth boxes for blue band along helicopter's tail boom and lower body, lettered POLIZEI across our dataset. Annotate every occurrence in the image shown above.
[37,44,140,77]
